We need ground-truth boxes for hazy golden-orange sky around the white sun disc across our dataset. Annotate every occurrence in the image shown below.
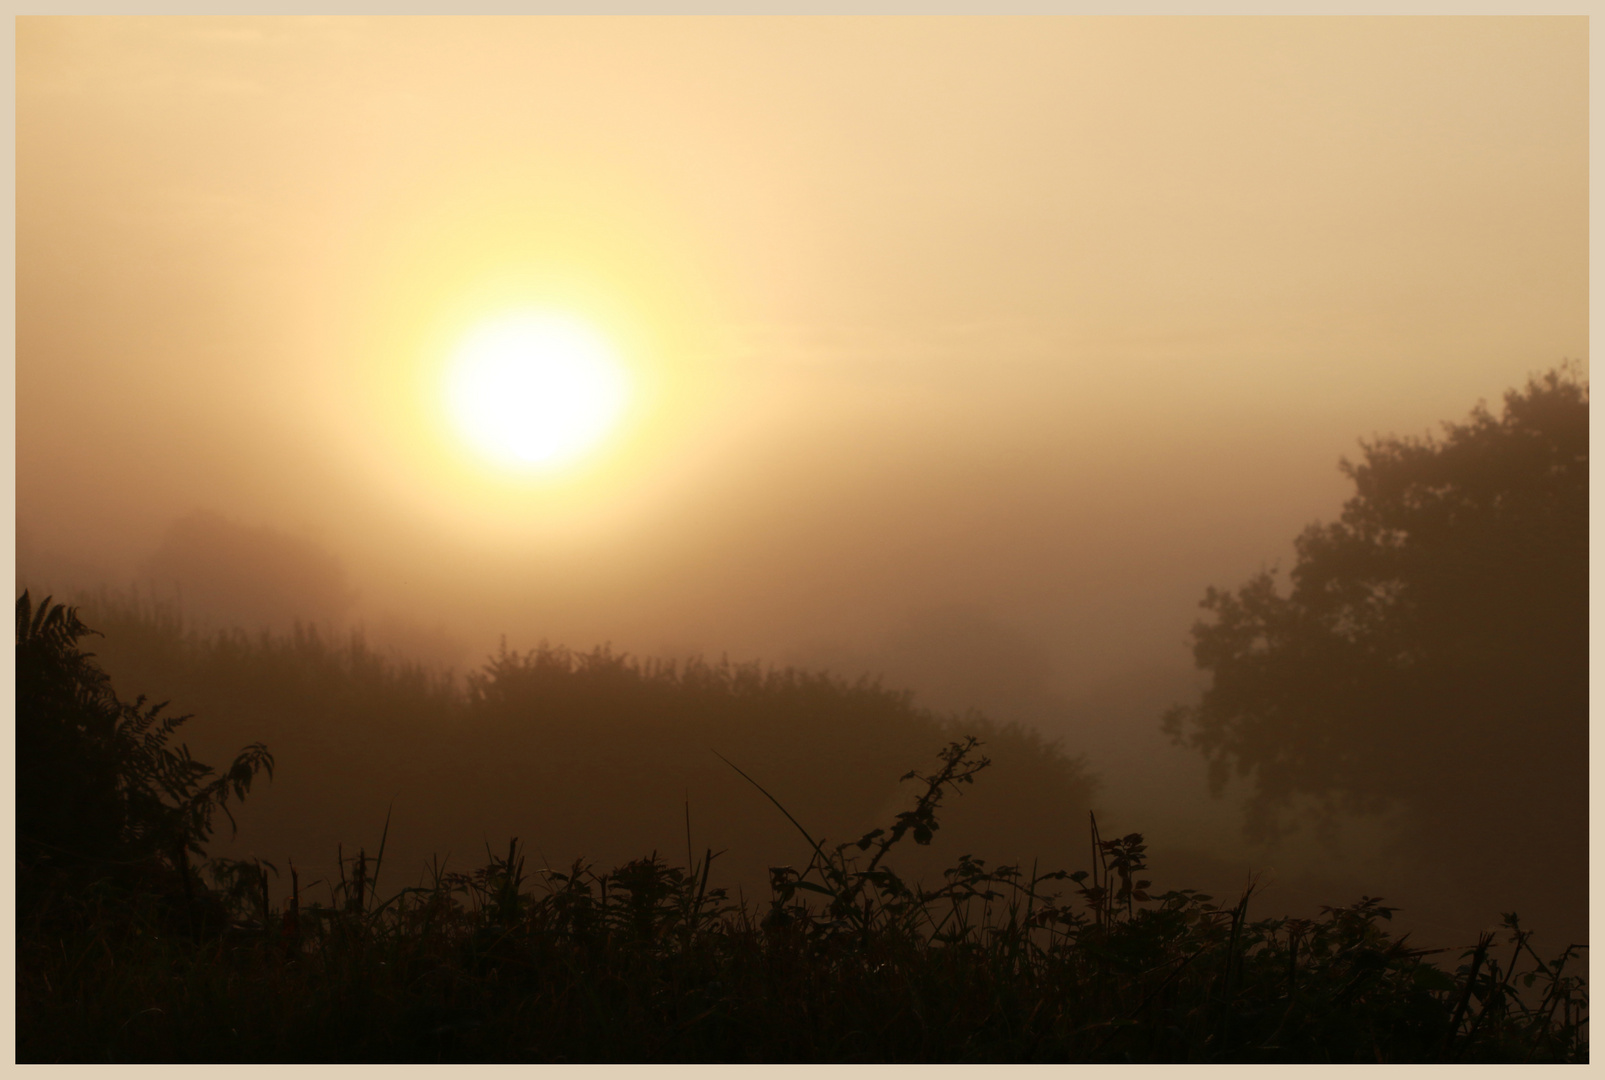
[16,18,1587,706]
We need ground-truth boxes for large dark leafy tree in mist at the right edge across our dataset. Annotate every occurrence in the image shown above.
[1164,369,1589,883]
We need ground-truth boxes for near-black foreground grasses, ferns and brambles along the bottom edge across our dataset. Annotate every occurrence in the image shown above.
[18,594,1587,1062]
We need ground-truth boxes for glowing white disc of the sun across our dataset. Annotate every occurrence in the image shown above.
[446,313,626,469]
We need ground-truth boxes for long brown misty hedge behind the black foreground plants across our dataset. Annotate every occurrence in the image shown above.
[69,589,1093,892]
